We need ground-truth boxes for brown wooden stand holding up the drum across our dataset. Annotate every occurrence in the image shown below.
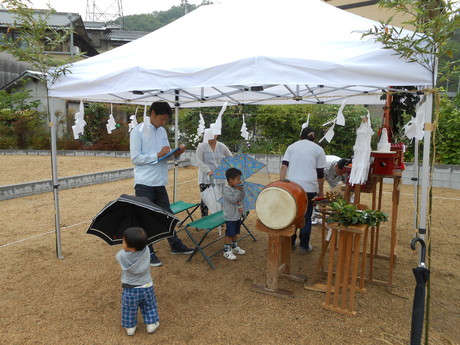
[252,220,306,298]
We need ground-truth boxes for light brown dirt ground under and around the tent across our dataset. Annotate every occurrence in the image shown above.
[0,156,460,345]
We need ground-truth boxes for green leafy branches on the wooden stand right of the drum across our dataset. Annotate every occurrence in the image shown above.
[327,199,388,226]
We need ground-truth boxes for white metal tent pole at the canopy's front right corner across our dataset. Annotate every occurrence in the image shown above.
[419,93,433,263]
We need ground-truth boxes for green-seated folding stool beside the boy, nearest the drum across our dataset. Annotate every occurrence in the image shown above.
[184,211,256,269]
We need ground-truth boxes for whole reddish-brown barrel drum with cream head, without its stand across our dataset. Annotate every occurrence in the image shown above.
[256,180,308,230]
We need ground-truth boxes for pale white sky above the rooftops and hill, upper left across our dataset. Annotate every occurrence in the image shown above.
[27,0,202,20]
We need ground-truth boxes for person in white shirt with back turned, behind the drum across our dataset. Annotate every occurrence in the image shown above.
[280,127,327,254]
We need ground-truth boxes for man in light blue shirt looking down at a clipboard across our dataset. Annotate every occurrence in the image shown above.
[130,102,193,266]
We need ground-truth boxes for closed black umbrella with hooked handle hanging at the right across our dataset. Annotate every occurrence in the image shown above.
[410,237,430,345]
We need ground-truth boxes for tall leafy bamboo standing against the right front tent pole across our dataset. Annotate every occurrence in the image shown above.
[363,0,460,344]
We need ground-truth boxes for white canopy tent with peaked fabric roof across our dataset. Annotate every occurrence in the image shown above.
[48,0,432,256]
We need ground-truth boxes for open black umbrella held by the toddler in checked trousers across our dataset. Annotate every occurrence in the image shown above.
[86,194,179,246]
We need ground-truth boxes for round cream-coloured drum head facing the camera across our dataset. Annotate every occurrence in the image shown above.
[256,187,297,230]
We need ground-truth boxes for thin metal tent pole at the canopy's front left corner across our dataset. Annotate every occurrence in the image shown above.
[47,97,64,259]
